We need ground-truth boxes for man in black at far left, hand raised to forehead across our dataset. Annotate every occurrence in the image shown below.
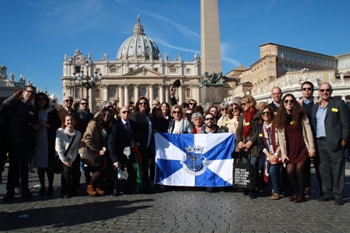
[3,86,39,201]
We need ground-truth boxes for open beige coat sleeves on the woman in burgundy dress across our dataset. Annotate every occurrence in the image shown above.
[277,114,315,157]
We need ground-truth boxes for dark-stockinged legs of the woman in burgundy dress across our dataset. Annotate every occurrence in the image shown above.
[287,161,306,198]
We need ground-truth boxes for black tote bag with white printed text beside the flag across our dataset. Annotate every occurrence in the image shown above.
[232,153,255,190]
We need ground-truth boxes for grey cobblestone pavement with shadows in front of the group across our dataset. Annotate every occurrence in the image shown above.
[0,164,350,232]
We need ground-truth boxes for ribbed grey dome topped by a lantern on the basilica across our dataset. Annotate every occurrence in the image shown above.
[117,16,160,60]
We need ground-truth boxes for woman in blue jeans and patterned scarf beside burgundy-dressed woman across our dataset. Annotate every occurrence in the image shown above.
[258,103,282,200]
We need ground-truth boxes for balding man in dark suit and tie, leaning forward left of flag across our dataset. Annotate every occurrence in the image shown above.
[108,106,139,193]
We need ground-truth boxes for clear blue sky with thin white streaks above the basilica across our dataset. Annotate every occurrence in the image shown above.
[0,0,350,102]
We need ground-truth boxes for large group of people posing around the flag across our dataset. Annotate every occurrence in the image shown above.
[1,81,349,205]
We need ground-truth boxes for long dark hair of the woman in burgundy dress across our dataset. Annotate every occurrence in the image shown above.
[273,94,305,129]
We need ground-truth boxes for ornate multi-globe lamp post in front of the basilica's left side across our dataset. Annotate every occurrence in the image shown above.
[72,61,102,108]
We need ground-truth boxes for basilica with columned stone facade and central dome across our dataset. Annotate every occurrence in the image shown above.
[61,18,200,111]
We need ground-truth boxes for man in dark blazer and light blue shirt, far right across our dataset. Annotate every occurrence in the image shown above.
[311,82,350,205]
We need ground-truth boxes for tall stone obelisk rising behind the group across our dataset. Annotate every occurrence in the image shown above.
[199,0,224,103]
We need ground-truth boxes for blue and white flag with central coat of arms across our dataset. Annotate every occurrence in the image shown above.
[155,133,235,187]
